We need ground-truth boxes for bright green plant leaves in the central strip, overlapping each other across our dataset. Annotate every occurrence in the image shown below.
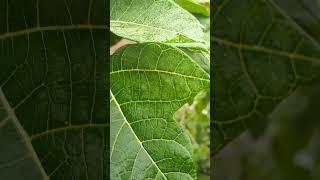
[110,0,210,179]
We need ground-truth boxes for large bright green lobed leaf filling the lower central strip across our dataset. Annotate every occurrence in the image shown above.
[110,43,210,179]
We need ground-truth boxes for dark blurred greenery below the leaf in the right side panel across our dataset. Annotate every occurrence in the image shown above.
[213,81,320,180]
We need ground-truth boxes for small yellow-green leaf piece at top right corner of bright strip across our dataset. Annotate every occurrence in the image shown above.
[174,0,210,16]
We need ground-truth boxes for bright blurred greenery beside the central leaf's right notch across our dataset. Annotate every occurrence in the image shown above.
[175,89,210,179]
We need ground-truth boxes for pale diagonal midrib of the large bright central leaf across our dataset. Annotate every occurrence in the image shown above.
[110,90,167,180]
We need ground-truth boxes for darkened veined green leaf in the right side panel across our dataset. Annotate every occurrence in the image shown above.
[211,0,320,152]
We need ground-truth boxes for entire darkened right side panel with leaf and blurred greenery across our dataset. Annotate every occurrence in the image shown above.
[215,0,320,180]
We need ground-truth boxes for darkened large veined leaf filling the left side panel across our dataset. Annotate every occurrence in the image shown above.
[0,0,109,180]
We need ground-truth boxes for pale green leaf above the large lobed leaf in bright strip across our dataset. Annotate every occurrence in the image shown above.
[110,0,204,45]
